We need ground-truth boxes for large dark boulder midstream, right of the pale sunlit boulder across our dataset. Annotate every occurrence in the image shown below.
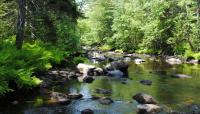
[105,61,129,77]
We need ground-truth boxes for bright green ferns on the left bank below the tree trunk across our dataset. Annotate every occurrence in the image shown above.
[0,38,68,95]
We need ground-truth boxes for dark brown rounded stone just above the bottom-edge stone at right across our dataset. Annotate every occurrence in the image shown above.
[133,93,157,104]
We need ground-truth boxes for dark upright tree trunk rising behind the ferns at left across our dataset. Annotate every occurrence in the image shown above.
[16,0,26,49]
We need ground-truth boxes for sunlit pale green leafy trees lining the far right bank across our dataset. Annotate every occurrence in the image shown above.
[79,0,200,54]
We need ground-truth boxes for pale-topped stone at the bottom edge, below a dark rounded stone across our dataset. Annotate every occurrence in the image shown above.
[137,104,162,114]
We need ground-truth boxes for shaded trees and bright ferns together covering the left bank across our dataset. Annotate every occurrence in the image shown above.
[0,0,81,95]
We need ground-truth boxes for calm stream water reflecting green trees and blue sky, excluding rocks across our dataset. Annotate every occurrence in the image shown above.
[0,60,200,114]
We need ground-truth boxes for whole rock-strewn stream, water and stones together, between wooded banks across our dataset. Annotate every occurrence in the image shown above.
[0,50,200,114]
